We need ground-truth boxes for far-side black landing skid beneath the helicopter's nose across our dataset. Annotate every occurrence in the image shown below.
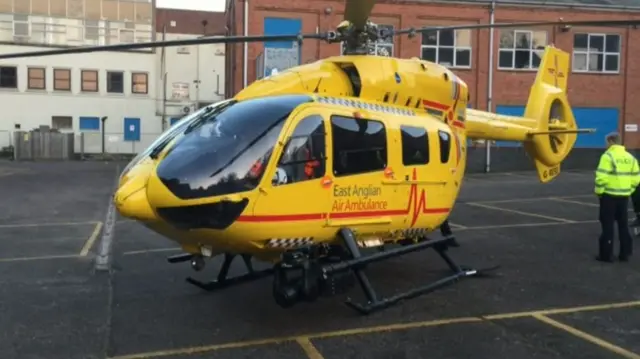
[168,253,273,292]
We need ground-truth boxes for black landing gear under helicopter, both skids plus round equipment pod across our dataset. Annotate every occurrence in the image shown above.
[168,228,499,314]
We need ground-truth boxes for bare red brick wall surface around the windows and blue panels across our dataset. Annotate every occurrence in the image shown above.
[227,0,640,148]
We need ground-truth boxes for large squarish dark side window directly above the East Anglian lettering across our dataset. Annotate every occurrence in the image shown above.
[331,115,387,176]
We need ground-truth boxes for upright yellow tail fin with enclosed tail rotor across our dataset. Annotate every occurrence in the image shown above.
[524,46,593,182]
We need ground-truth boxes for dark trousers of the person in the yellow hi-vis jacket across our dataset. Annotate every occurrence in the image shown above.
[599,194,633,260]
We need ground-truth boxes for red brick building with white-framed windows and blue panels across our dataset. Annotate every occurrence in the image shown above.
[226,0,640,172]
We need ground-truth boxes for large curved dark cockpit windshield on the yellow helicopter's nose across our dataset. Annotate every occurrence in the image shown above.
[157,95,311,199]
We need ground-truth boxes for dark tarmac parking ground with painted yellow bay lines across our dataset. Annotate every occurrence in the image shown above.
[0,162,640,359]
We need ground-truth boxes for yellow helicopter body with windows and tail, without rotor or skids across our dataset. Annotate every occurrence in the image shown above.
[115,47,576,261]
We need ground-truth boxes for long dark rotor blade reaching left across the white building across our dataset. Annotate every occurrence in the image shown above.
[0,34,326,59]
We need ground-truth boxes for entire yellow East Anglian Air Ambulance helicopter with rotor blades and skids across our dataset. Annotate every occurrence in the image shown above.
[0,0,637,313]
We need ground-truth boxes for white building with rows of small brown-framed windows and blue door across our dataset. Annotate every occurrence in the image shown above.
[0,0,224,153]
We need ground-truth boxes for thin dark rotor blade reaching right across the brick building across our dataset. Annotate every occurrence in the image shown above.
[391,20,640,35]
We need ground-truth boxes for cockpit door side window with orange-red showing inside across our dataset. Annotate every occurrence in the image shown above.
[272,115,326,185]
